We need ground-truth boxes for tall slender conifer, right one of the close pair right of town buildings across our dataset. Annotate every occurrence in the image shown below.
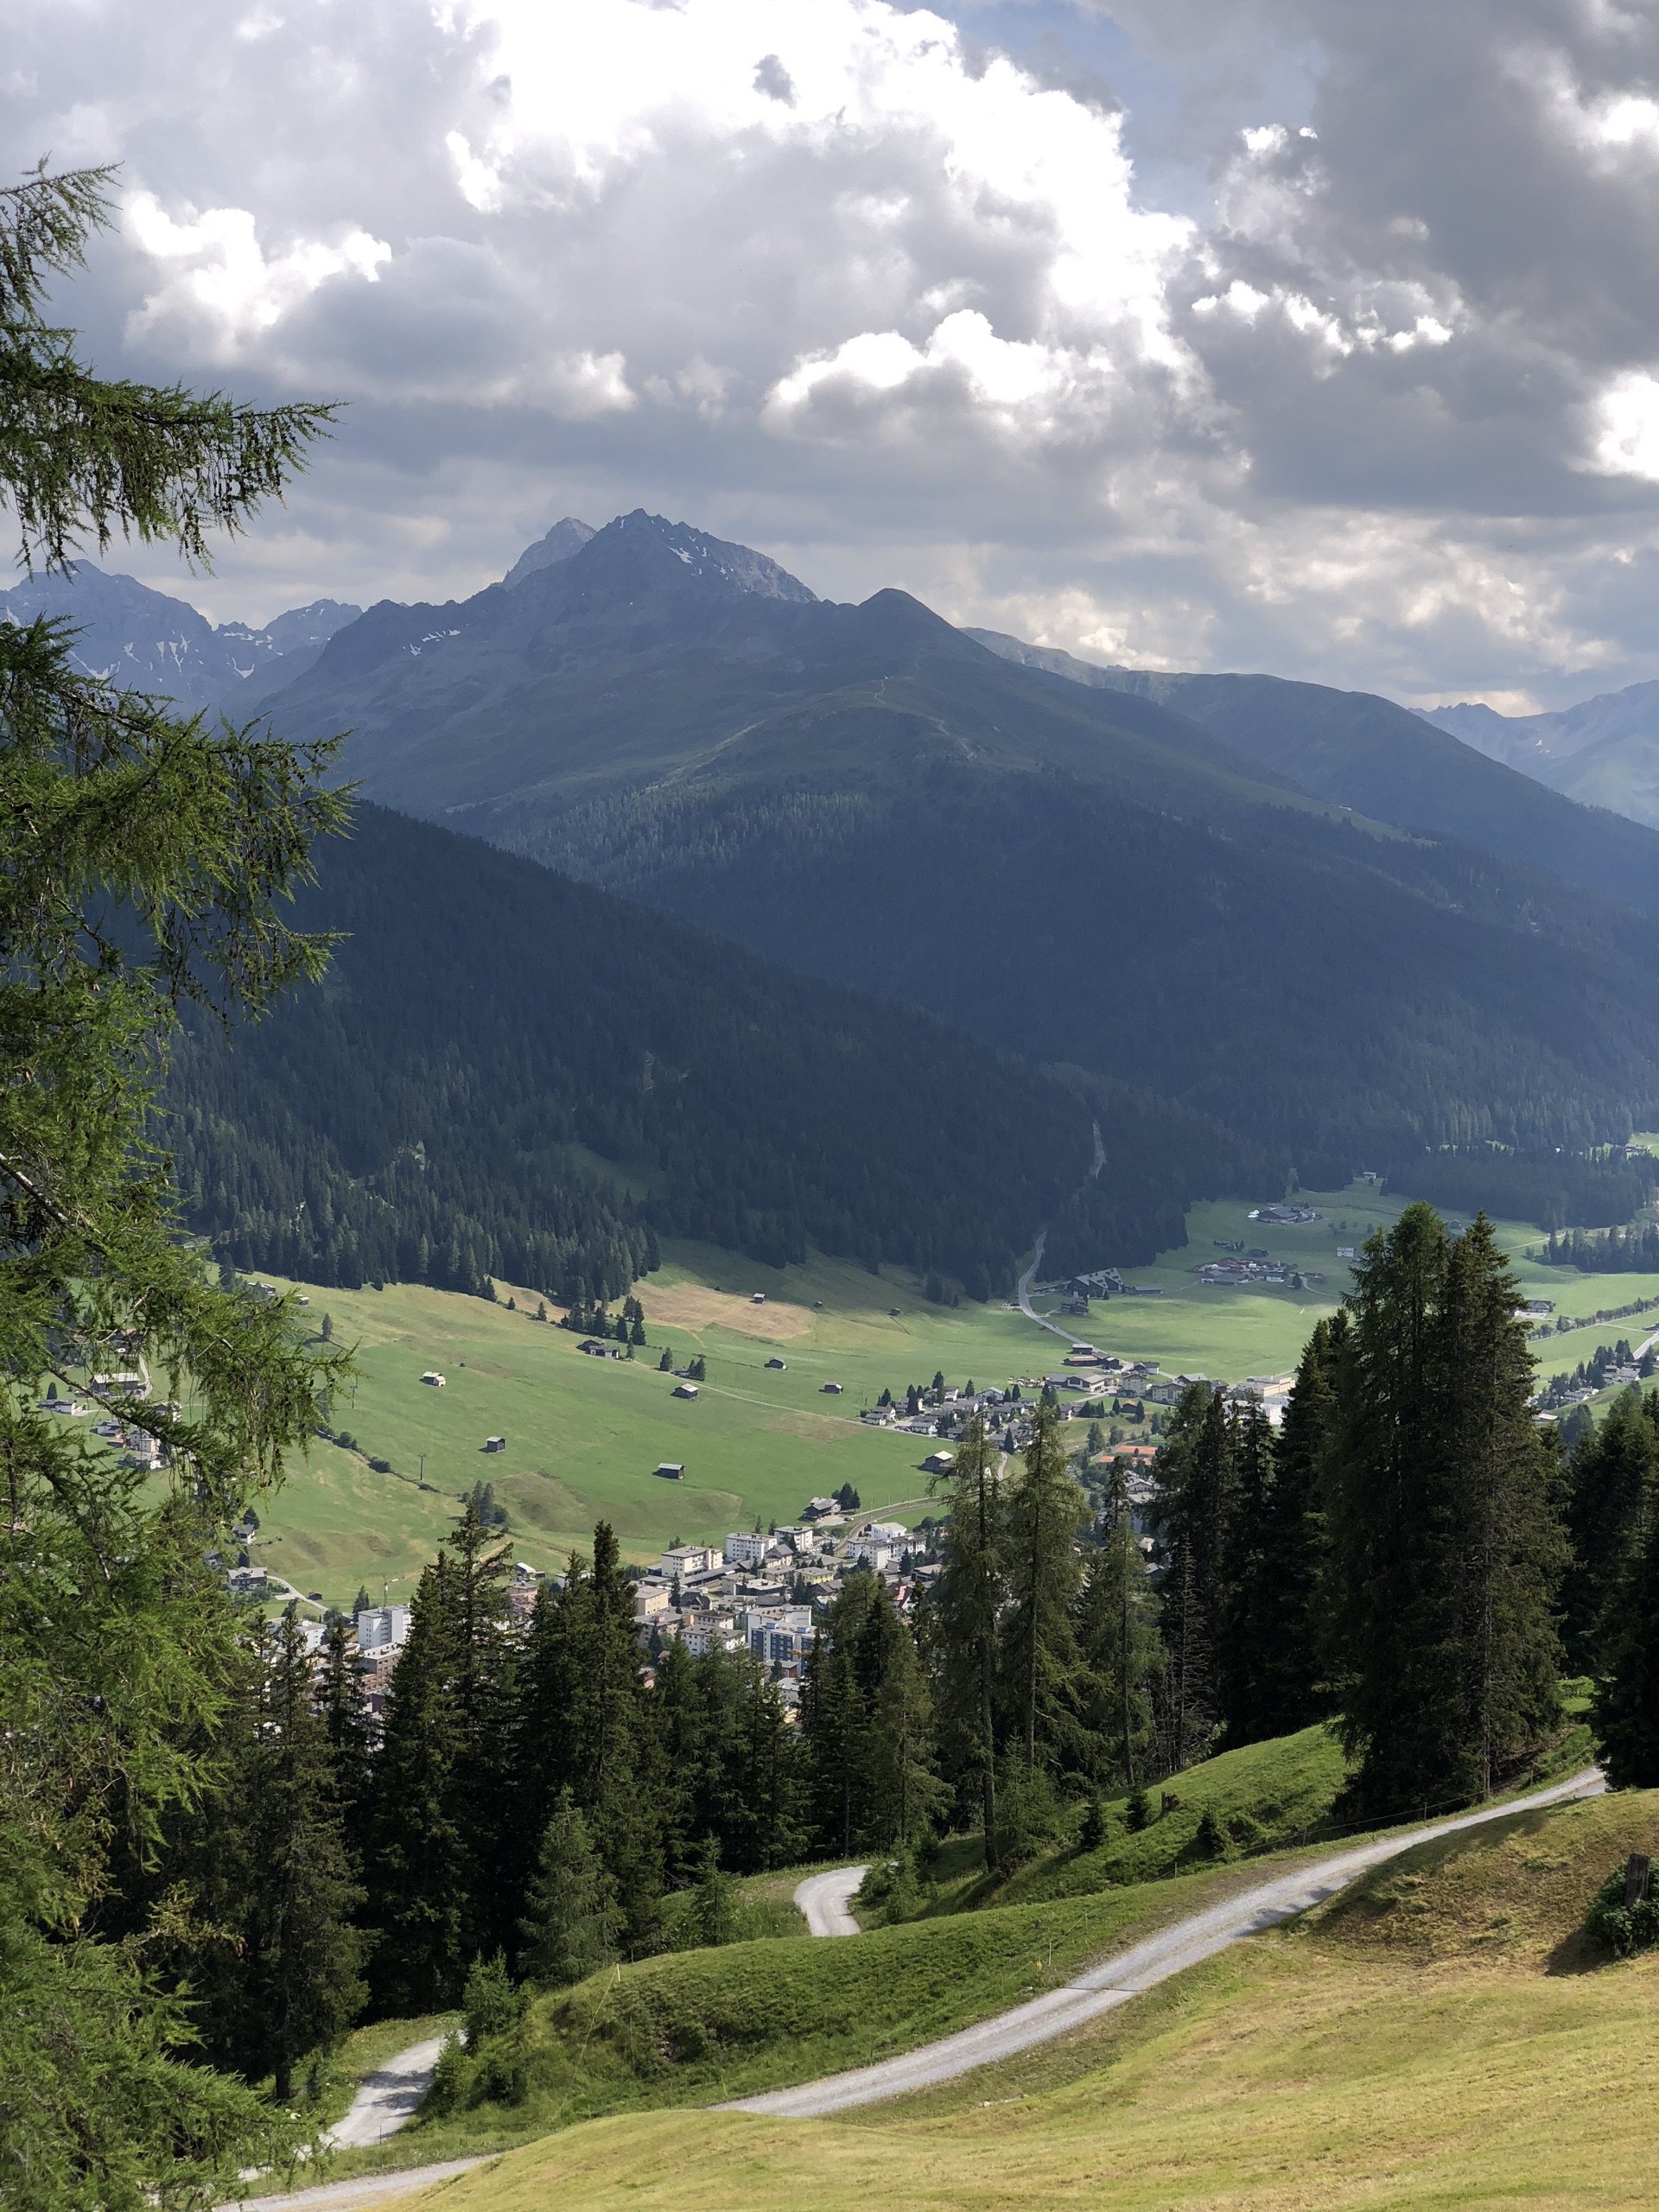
[1000,1407,1095,1774]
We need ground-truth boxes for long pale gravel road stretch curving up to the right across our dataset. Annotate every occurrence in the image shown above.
[715,1767,1606,2119]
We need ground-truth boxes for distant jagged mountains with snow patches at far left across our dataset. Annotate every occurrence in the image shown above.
[0,562,363,712]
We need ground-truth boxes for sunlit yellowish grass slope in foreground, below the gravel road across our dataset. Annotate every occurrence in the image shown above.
[389,1794,1659,2212]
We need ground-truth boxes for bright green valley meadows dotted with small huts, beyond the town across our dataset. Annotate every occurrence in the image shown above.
[234,1185,1659,1604]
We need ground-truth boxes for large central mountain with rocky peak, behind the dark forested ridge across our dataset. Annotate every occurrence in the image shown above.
[32,511,1659,1261]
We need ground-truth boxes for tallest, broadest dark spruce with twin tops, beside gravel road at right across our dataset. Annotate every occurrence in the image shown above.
[1327,1205,1566,1814]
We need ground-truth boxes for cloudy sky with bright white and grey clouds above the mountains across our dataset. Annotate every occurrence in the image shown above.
[16,0,1659,712]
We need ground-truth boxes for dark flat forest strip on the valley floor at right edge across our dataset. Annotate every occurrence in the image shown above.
[1380,1144,1659,1238]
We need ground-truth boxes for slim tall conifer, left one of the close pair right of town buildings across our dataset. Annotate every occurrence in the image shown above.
[929,1414,1007,1869]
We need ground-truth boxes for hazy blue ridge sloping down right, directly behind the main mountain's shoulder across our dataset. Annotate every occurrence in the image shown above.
[969,631,1659,913]
